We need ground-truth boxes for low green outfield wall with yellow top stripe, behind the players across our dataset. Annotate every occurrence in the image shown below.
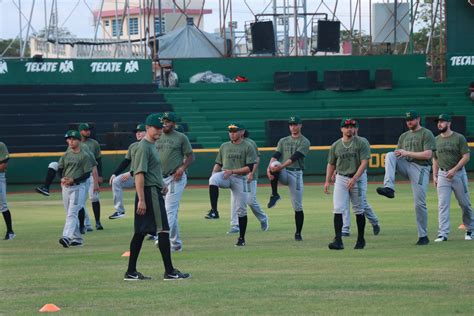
[7,143,474,184]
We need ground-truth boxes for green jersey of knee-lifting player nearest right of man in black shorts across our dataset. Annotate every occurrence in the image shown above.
[216,140,257,170]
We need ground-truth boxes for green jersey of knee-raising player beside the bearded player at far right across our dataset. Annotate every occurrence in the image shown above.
[397,127,436,166]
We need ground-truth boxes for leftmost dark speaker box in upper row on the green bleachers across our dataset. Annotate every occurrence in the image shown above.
[273,71,318,92]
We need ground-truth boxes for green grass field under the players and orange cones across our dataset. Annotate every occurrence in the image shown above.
[0,185,474,315]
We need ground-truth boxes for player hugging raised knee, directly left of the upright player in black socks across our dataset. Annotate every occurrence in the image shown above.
[267,115,310,241]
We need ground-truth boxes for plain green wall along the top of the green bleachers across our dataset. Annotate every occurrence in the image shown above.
[173,55,426,84]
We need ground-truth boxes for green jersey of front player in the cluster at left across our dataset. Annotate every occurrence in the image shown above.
[58,147,97,179]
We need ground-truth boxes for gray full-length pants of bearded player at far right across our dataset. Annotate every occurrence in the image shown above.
[436,168,474,238]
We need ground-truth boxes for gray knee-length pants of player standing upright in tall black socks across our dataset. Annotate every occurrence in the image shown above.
[333,174,367,215]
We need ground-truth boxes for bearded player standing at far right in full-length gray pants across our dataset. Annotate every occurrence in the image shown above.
[433,114,474,242]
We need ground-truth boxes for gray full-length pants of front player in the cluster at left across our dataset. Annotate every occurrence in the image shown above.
[62,183,86,243]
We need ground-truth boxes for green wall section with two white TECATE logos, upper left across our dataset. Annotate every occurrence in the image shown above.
[0,59,153,85]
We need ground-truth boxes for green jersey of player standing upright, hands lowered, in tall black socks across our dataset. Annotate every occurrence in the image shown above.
[328,136,370,175]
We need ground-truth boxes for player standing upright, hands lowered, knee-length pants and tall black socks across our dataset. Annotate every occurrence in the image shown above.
[324,119,370,250]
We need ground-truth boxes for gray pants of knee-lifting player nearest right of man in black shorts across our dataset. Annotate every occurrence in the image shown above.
[209,171,249,217]
